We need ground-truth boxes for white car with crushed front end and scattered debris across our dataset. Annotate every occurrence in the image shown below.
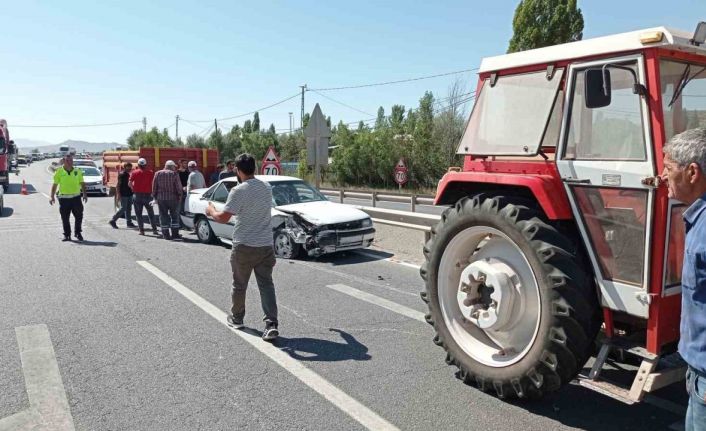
[182,175,375,259]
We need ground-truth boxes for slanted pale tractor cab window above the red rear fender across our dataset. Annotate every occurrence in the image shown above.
[457,69,564,156]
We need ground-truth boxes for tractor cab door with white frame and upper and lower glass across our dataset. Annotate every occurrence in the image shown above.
[556,55,656,317]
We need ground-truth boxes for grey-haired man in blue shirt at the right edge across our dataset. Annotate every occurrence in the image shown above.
[662,128,706,431]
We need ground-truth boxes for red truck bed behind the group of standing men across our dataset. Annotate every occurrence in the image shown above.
[103,148,219,196]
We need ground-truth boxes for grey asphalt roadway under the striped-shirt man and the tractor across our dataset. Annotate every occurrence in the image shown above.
[0,161,684,431]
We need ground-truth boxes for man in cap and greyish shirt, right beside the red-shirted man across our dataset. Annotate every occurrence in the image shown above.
[152,160,183,239]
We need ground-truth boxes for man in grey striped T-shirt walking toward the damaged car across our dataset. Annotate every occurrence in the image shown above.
[206,154,279,341]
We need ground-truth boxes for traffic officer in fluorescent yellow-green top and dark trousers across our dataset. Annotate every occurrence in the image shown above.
[49,154,88,241]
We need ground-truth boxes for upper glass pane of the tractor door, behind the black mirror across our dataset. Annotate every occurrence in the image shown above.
[564,62,647,161]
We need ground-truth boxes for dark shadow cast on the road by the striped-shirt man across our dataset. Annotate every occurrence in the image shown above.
[245,328,372,362]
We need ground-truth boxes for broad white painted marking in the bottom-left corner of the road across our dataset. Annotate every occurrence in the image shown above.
[0,325,74,431]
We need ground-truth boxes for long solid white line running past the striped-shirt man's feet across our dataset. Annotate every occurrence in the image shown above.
[137,261,398,430]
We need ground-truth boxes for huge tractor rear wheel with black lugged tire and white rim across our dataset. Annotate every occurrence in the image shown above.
[420,195,600,399]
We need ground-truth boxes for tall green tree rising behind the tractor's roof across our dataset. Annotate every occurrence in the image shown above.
[507,0,583,52]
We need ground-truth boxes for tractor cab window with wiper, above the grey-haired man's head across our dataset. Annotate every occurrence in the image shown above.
[659,61,706,140]
